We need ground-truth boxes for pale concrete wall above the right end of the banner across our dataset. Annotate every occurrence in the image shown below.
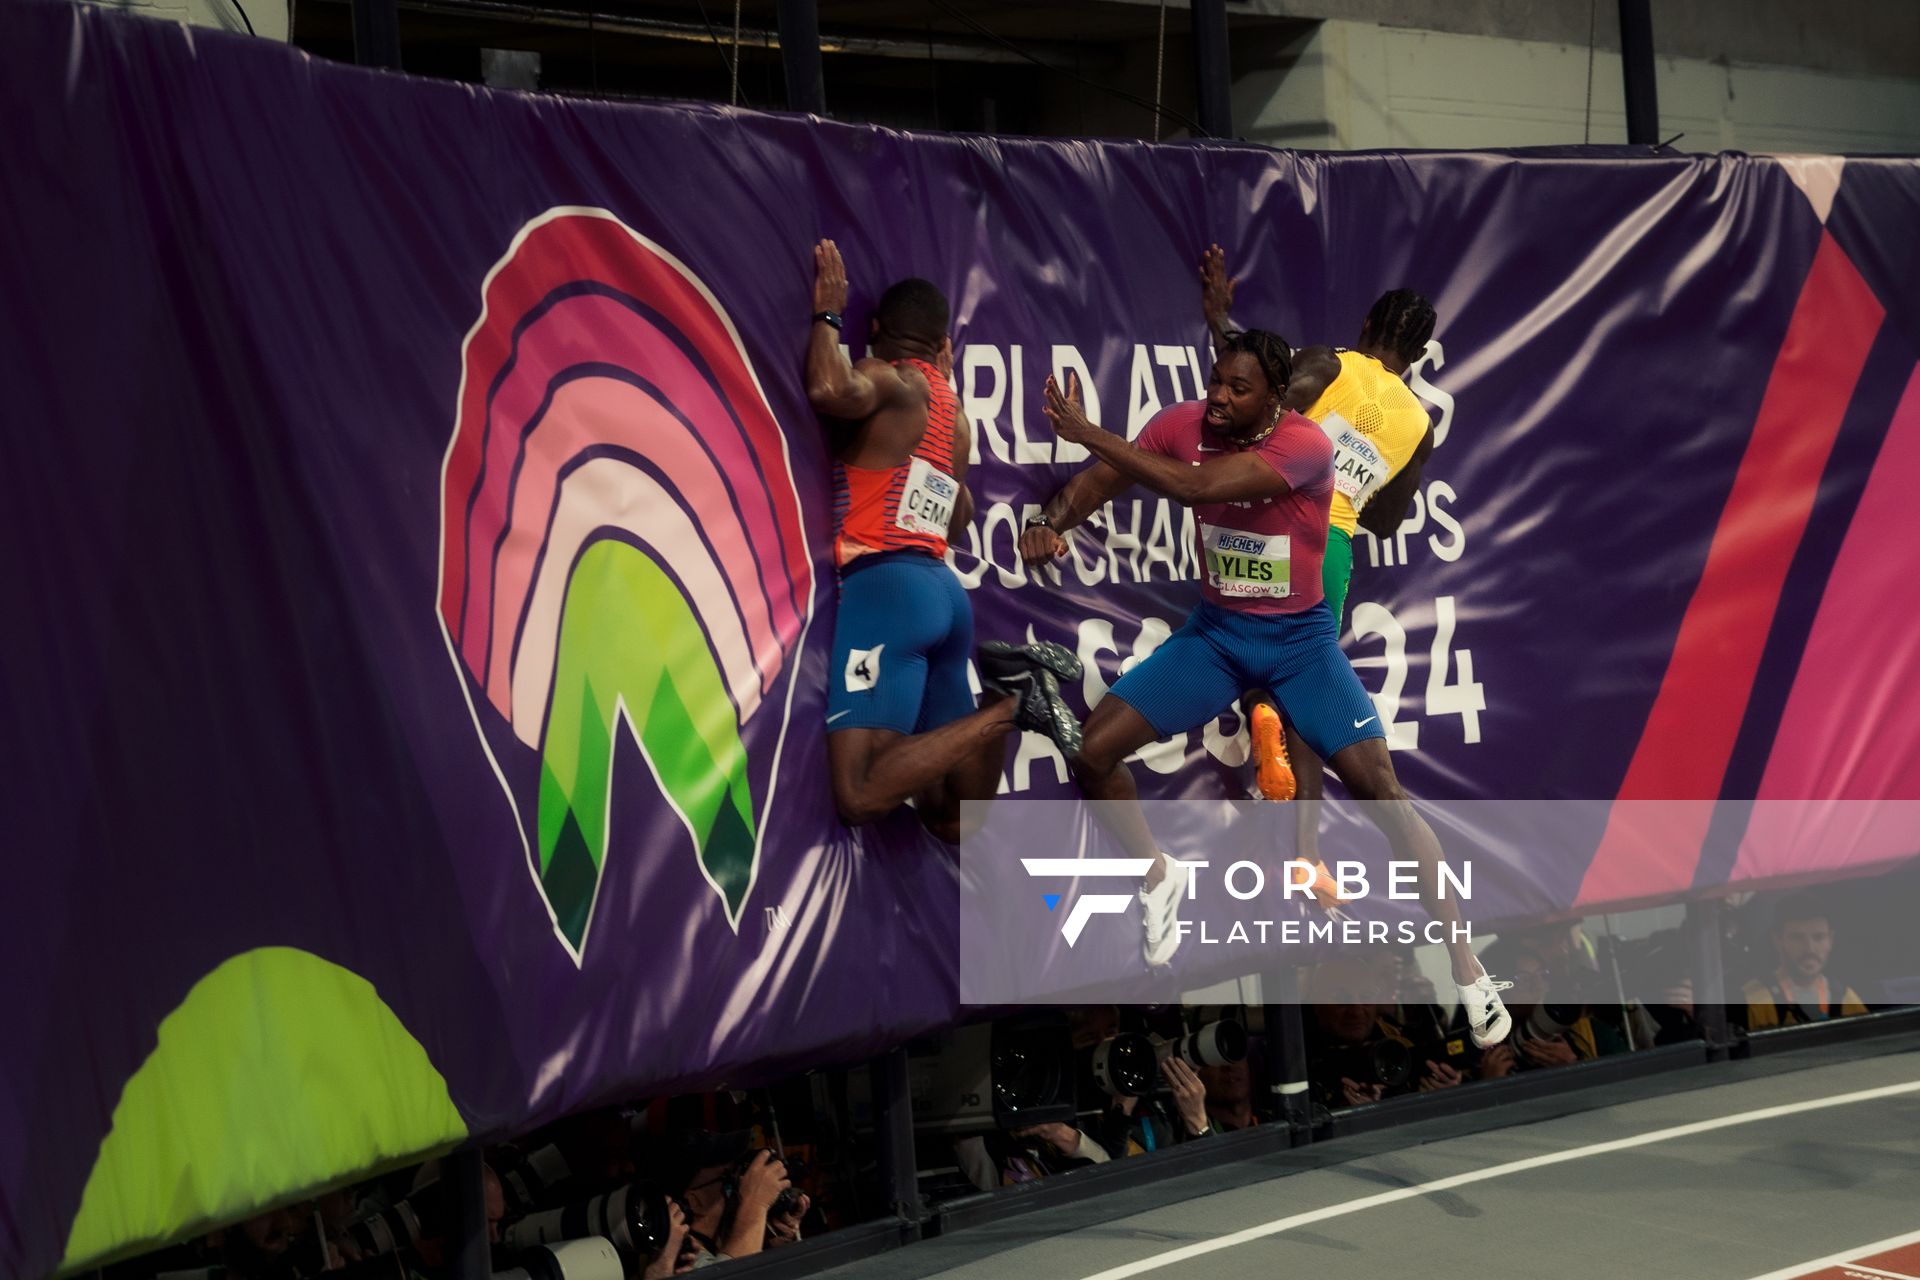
[1233,19,1920,155]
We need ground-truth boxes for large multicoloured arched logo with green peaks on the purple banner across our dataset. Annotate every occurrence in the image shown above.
[438,207,814,963]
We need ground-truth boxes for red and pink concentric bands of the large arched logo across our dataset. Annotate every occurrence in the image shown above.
[440,209,814,718]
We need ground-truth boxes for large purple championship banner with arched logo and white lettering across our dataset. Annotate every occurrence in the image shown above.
[0,4,1920,1274]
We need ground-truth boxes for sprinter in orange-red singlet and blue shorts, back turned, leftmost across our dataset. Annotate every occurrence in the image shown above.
[806,240,1081,841]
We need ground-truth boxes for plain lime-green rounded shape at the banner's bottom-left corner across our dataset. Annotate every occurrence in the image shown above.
[60,946,467,1272]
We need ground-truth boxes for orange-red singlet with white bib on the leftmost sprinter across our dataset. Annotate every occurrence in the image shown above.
[833,359,960,568]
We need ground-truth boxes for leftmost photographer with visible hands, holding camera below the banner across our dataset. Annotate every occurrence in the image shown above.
[682,1130,812,1270]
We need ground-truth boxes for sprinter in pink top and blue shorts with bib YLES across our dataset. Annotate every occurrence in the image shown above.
[1020,330,1513,1048]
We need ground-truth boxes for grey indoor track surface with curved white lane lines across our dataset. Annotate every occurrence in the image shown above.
[822,1050,1920,1280]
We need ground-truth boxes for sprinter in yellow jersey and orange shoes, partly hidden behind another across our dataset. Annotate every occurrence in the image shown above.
[1200,244,1434,890]
